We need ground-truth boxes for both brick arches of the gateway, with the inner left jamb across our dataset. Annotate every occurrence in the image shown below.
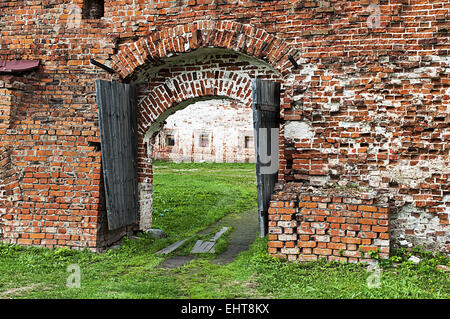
[107,20,299,229]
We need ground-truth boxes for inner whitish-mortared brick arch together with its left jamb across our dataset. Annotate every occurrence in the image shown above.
[137,70,252,229]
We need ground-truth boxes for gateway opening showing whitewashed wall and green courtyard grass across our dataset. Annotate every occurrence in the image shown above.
[152,99,258,242]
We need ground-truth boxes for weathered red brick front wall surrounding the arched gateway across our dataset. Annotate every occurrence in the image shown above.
[0,0,450,251]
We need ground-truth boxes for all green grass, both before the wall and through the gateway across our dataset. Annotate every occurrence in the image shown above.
[0,162,450,299]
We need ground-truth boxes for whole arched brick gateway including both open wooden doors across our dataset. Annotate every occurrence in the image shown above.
[96,21,296,248]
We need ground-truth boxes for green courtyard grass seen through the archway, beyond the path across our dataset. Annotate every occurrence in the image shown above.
[153,162,256,237]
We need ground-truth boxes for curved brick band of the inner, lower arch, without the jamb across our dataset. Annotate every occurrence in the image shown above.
[138,71,252,135]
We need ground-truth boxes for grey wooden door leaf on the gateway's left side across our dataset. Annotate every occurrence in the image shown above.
[95,80,138,230]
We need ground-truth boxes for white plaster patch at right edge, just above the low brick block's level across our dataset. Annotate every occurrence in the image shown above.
[383,159,450,187]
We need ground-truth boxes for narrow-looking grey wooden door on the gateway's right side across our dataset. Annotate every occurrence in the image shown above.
[252,79,280,237]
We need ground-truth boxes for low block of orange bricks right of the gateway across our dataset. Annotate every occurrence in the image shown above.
[269,185,390,262]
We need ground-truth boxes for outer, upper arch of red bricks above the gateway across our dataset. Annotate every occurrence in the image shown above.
[112,20,298,78]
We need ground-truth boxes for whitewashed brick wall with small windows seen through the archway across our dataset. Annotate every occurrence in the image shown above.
[152,100,255,163]
